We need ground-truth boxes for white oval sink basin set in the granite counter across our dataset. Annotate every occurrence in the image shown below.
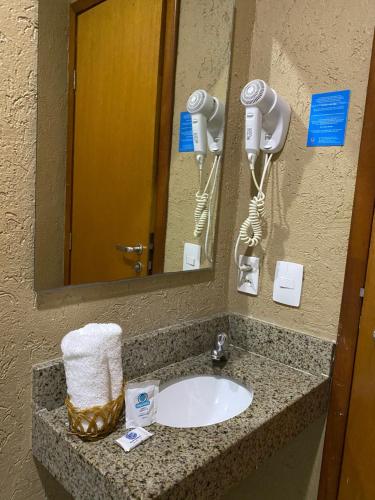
[156,375,253,428]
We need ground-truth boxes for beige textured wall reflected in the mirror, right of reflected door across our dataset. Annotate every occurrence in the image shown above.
[164,0,234,272]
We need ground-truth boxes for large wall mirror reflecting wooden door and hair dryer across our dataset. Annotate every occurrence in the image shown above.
[34,0,234,290]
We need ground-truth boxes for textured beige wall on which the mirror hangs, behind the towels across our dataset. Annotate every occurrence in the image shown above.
[0,0,251,500]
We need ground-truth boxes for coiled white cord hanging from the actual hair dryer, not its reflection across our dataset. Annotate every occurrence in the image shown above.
[234,154,272,270]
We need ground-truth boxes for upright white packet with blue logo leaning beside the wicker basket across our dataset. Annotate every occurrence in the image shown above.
[125,380,160,429]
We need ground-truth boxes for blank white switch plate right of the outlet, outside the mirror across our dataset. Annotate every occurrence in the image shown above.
[273,260,303,307]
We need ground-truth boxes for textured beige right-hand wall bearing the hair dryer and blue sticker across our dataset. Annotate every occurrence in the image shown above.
[229,0,375,339]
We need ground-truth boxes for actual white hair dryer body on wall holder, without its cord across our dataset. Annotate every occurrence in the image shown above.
[241,80,291,165]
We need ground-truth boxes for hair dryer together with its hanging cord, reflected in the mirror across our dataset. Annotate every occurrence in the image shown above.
[186,90,225,263]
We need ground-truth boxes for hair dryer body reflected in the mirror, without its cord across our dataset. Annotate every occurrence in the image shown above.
[186,89,225,163]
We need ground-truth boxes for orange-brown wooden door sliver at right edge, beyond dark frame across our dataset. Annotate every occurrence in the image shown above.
[338,213,375,500]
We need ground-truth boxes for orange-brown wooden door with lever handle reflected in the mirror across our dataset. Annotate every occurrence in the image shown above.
[67,0,164,284]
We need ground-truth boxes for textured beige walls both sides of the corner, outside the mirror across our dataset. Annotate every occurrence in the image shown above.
[0,0,375,500]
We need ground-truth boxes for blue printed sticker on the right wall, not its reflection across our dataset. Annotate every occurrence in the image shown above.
[307,90,350,146]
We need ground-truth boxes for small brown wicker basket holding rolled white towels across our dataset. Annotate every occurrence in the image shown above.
[65,387,124,441]
